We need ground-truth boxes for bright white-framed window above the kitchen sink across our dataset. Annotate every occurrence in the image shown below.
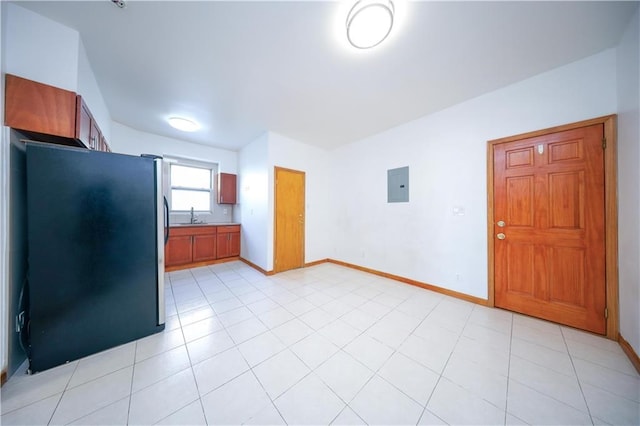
[169,163,214,212]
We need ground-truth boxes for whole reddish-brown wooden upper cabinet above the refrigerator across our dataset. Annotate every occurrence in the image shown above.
[4,74,111,151]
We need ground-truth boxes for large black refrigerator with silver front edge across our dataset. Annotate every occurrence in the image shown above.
[23,142,168,373]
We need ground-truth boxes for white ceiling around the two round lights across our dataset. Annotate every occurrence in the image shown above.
[8,0,638,149]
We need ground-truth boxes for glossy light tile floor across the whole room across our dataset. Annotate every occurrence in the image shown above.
[1,262,640,425]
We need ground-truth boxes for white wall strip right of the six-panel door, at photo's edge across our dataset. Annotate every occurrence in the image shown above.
[617,11,640,354]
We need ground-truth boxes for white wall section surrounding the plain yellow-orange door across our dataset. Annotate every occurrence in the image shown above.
[268,132,333,270]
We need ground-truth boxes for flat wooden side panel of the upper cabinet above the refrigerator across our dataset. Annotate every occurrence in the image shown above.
[4,74,76,138]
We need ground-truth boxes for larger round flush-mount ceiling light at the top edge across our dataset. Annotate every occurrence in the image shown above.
[347,0,394,49]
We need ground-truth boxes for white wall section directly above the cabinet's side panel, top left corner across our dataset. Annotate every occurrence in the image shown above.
[3,3,80,92]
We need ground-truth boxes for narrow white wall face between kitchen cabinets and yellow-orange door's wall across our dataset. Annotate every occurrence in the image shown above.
[239,133,273,270]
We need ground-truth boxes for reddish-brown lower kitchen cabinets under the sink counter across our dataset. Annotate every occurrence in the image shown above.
[165,225,240,267]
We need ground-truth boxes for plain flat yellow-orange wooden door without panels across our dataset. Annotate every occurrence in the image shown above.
[273,167,305,272]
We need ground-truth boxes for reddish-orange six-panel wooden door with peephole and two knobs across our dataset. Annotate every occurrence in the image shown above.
[493,124,606,334]
